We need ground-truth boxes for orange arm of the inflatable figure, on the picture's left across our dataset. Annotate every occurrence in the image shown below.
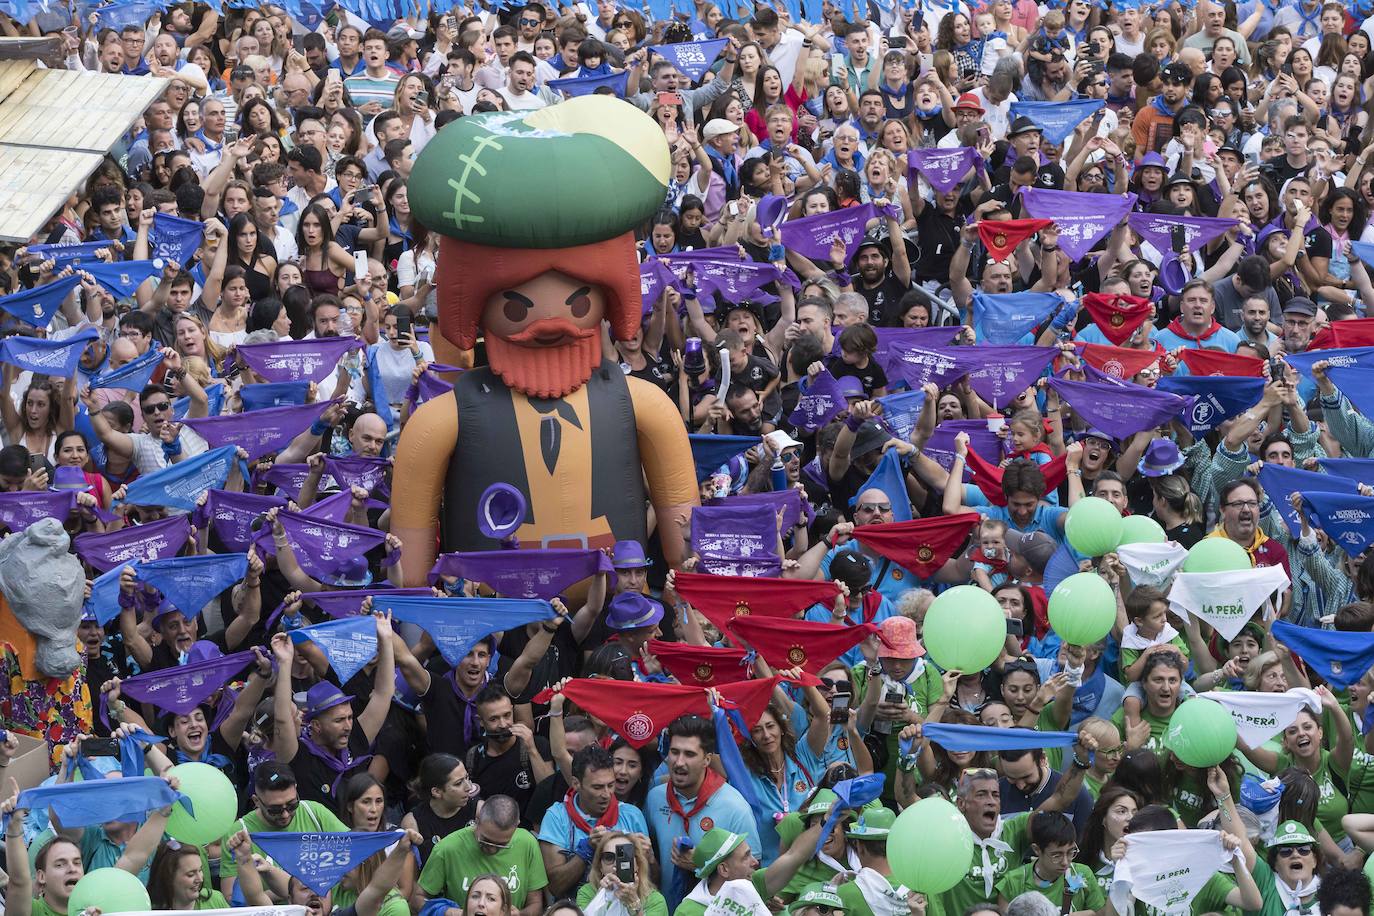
[392,397,461,586]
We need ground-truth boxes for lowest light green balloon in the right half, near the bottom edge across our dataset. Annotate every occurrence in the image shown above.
[888,797,973,894]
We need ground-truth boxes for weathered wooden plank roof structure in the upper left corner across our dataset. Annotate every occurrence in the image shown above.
[0,38,168,243]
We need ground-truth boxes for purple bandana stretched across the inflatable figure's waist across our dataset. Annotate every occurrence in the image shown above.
[430,548,614,602]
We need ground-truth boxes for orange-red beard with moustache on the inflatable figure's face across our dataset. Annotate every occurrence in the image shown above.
[486,319,602,398]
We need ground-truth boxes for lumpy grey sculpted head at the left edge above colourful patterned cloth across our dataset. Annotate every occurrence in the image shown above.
[0,518,85,677]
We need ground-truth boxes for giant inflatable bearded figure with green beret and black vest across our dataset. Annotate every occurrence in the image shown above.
[392,95,697,585]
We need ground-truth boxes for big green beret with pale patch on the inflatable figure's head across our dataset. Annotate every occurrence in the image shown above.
[409,95,672,249]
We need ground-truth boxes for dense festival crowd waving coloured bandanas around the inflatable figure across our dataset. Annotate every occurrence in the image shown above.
[0,0,1374,916]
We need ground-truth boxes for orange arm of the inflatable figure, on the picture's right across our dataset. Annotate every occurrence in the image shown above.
[629,376,698,573]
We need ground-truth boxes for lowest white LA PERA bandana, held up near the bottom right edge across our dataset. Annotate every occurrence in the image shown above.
[1112,829,1245,913]
